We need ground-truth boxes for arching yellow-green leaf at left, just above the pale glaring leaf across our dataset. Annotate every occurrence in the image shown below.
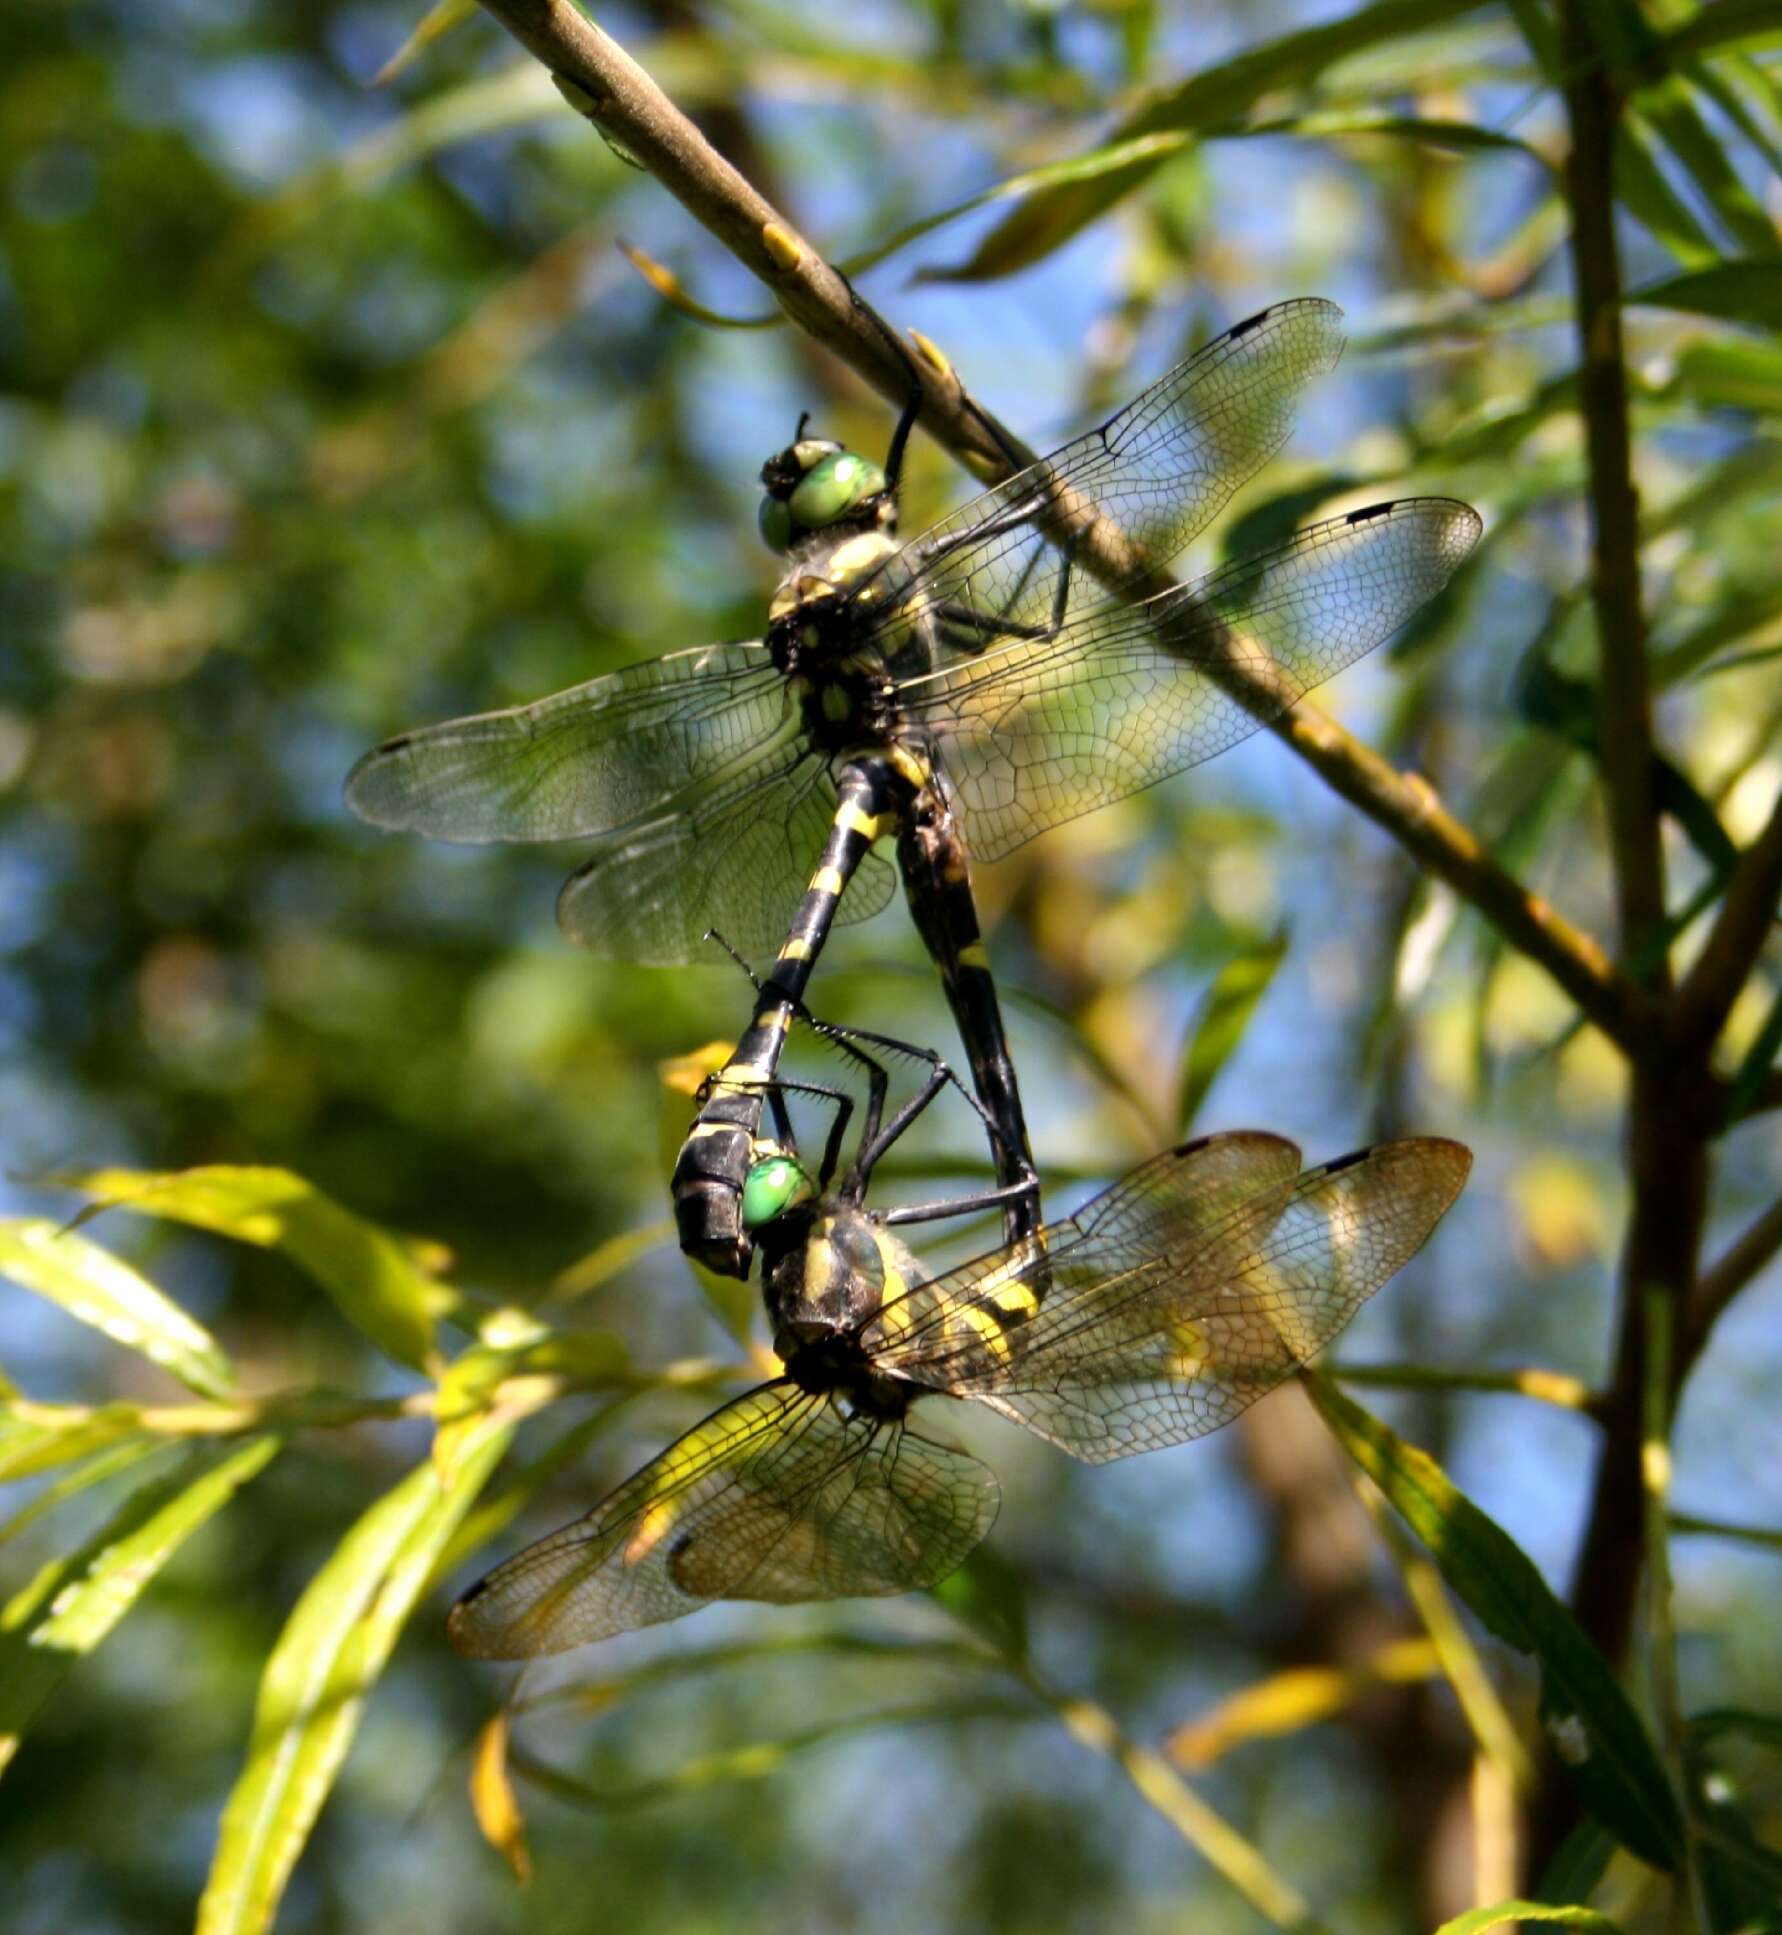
[60,1165,451,1370]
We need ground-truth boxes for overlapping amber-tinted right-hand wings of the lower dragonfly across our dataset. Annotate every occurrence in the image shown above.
[875,1136,1472,1465]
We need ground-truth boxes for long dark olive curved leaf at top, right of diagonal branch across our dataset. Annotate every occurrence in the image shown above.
[931,0,1482,283]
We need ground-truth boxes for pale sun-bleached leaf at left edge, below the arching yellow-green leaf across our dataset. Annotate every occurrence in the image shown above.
[0,1217,234,1397]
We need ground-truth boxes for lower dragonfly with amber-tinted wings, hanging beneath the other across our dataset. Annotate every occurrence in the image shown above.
[447,1037,1472,1660]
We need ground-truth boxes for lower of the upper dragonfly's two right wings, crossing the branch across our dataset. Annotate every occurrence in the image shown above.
[900,497,1482,859]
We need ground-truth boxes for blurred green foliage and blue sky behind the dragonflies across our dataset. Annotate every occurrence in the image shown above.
[0,0,1782,1935]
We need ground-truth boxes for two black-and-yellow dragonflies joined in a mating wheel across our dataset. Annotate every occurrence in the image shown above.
[346,300,1480,1651]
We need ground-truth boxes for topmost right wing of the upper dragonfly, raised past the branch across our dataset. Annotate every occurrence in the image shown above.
[870,300,1343,650]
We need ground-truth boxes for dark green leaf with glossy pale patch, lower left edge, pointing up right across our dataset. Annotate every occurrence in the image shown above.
[0,1438,279,1769]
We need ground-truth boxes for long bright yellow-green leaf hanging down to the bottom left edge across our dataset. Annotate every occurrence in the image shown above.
[197,1414,513,1935]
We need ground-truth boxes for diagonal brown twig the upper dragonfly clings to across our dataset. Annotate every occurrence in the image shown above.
[470,0,1650,1053]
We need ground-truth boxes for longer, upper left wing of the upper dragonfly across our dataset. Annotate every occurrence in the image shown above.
[346,644,799,844]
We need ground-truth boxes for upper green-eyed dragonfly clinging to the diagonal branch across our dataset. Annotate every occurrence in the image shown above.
[346,298,1480,1275]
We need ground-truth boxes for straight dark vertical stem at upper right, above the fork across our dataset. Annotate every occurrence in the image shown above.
[1559,0,1670,989]
